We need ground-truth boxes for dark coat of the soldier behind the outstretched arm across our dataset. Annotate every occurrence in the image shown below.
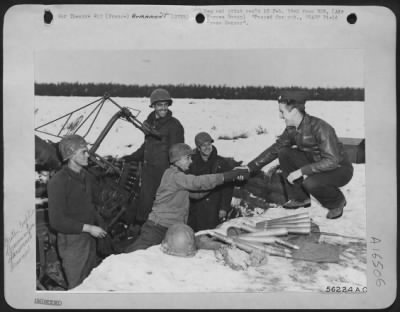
[188,146,233,232]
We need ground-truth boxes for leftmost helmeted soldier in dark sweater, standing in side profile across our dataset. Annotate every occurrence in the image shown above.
[48,135,107,289]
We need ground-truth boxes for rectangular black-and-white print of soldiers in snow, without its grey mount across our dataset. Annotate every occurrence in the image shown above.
[35,49,367,292]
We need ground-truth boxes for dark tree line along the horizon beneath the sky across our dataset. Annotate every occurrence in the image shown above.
[35,82,364,101]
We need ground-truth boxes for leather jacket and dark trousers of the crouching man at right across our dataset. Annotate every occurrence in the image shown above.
[248,114,353,209]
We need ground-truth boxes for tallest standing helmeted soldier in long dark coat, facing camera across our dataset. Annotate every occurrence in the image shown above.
[123,88,184,224]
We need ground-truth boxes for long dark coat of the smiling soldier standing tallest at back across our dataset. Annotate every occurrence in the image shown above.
[124,111,184,222]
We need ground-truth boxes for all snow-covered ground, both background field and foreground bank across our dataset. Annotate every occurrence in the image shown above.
[35,97,367,292]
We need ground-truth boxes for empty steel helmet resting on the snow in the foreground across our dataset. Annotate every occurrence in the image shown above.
[161,223,197,257]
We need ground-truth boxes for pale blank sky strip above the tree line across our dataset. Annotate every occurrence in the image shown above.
[35,49,364,87]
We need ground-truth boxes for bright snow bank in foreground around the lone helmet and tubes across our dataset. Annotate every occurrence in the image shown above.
[71,165,367,293]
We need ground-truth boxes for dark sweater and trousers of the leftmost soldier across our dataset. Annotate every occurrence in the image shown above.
[48,165,99,289]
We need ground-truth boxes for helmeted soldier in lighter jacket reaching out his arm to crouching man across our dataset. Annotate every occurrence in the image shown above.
[126,143,248,252]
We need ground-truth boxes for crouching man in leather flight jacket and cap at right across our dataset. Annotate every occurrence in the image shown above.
[247,91,353,219]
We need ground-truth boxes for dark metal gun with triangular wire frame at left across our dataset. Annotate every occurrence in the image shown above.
[35,94,160,289]
